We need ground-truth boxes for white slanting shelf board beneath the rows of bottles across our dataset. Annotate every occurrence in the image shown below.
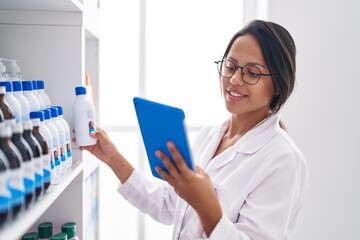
[0,163,83,240]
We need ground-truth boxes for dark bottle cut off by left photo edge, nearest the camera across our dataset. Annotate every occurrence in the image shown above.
[0,149,11,227]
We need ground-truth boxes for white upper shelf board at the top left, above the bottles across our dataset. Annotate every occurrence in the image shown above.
[0,0,100,38]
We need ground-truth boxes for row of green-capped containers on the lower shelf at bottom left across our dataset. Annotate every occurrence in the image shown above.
[21,222,79,240]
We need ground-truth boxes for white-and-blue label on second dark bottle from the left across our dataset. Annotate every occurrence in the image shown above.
[8,168,25,206]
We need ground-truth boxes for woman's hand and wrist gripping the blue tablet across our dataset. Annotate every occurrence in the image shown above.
[155,142,222,236]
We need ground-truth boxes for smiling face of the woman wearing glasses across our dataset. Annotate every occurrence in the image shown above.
[221,35,274,116]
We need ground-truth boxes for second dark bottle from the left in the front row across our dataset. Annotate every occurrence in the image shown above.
[0,123,25,218]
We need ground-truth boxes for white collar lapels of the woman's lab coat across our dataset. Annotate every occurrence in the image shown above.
[206,114,280,172]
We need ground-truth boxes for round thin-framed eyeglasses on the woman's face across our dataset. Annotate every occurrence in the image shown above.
[215,59,271,85]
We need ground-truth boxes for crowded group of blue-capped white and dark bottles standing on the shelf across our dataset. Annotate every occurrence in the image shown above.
[0,81,72,225]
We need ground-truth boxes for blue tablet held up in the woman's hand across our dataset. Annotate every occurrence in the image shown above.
[134,97,194,179]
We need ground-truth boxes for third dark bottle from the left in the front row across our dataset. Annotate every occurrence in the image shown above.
[11,123,35,208]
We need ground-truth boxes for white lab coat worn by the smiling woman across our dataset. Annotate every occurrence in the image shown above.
[118,115,307,240]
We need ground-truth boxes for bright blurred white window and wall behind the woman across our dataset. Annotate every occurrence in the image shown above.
[98,0,360,240]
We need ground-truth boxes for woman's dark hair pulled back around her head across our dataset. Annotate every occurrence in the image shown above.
[223,20,296,113]
